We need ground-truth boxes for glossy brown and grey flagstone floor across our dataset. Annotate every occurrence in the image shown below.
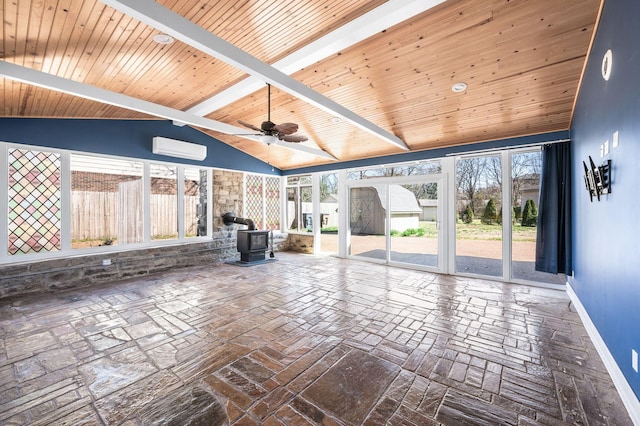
[0,253,631,426]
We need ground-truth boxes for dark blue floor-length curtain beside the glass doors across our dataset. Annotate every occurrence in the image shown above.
[536,142,571,275]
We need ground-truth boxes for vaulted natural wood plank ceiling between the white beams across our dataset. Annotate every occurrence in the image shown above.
[0,0,601,169]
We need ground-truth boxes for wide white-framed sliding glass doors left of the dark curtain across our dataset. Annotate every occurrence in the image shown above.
[340,147,565,284]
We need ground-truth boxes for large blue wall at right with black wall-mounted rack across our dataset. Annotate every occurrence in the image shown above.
[570,0,640,396]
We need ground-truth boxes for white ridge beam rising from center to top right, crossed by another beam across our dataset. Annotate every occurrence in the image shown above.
[187,0,444,116]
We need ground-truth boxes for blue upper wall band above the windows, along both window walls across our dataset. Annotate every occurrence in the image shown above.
[0,118,569,175]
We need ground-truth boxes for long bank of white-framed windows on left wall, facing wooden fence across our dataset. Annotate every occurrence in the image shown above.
[0,143,214,264]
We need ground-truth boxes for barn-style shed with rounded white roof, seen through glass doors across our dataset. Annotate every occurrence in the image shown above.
[350,185,422,235]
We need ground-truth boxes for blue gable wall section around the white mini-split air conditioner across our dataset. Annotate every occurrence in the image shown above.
[0,118,281,175]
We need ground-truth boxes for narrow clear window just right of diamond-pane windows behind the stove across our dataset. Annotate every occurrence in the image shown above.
[287,175,313,232]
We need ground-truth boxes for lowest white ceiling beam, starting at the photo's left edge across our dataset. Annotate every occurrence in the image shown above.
[0,60,336,160]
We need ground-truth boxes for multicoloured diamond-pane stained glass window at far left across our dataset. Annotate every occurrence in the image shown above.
[8,149,61,255]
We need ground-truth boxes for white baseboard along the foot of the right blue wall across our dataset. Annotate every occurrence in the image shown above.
[567,283,640,426]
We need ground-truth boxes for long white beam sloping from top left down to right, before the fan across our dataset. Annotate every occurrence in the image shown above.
[101,0,409,150]
